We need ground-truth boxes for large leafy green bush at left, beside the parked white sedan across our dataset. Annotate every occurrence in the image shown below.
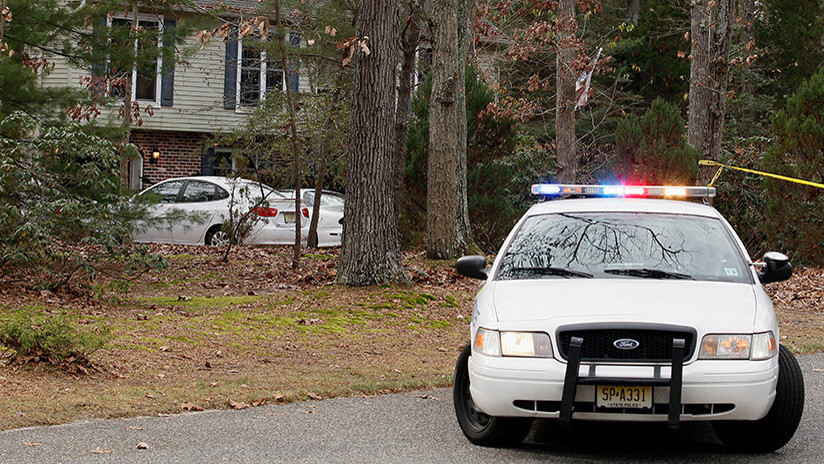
[0,113,162,289]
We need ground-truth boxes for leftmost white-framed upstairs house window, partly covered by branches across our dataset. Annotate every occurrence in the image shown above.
[108,16,163,105]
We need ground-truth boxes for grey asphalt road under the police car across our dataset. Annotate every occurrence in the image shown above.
[0,354,824,463]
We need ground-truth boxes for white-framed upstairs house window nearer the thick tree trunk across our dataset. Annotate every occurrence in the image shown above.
[236,41,286,108]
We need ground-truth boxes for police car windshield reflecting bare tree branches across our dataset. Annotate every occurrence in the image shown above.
[498,212,752,283]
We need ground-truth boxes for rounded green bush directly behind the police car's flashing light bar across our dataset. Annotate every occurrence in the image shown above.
[612,98,699,185]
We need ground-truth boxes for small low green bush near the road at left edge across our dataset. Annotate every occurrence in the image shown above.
[0,308,112,365]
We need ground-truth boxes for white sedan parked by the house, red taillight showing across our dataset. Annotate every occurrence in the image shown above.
[133,176,309,246]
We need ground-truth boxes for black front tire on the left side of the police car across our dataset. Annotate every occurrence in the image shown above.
[452,344,532,447]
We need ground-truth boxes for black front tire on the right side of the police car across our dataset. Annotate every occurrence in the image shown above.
[713,346,804,453]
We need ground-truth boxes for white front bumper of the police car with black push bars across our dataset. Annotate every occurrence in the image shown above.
[469,340,778,427]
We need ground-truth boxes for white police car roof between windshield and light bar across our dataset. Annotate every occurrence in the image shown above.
[526,198,721,218]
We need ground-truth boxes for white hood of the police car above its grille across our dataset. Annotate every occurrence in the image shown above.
[491,279,757,331]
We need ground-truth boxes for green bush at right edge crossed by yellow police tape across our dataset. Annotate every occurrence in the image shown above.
[763,68,824,265]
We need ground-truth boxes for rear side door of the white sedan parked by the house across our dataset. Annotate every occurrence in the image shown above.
[172,179,226,245]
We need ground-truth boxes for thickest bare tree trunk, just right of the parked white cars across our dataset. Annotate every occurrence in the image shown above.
[337,0,407,285]
